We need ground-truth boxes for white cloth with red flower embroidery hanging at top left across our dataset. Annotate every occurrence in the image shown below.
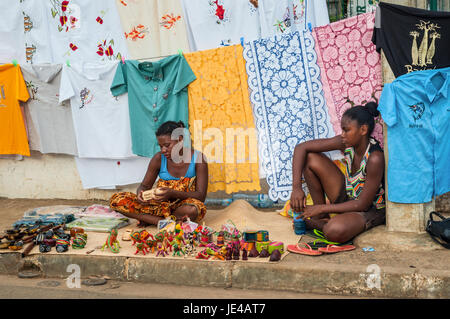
[43,0,128,63]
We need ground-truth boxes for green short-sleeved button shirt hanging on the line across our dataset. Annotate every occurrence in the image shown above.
[111,54,196,157]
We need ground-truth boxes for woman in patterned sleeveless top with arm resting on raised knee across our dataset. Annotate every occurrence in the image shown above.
[291,102,385,243]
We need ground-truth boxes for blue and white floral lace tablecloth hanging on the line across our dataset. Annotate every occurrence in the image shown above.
[244,30,334,200]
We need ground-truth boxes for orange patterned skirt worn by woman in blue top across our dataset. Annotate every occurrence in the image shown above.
[109,177,206,222]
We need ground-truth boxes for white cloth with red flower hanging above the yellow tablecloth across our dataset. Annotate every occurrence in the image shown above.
[182,0,261,51]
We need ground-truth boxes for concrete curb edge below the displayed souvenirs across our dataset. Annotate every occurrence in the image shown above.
[0,252,450,298]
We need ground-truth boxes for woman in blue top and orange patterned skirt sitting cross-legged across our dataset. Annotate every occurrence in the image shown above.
[110,121,208,226]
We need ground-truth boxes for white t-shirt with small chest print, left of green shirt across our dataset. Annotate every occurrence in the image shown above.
[59,62,135,158]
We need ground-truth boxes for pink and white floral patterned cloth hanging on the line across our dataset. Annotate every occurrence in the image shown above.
[313,12,383,144]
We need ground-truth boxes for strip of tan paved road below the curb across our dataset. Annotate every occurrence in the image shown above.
[0,275,358,299]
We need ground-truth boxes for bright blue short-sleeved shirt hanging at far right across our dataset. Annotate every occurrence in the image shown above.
[379,68,450,203]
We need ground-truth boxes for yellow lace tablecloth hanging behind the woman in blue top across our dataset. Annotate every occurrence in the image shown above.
[184,45,261,193]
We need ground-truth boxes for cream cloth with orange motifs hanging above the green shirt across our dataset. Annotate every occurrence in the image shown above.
[116,0,189,59]
